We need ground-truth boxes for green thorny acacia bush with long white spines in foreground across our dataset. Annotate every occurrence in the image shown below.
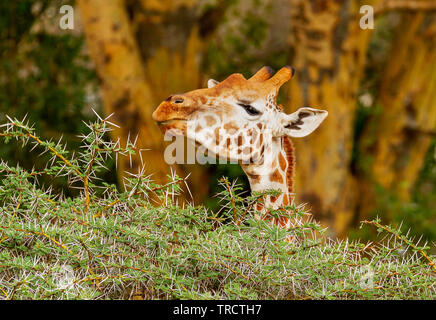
[0,118,436,299]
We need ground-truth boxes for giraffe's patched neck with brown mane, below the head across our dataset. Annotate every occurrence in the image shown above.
[242,136,295,209]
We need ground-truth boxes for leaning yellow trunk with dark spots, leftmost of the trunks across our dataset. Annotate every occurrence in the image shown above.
[77,0,169,183]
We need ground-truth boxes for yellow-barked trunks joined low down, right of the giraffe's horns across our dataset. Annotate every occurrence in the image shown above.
[289,0,436,237]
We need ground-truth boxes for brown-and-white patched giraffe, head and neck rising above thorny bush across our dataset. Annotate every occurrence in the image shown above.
[152,66,328,227]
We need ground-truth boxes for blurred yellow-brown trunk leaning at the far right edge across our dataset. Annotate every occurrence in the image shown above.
[359,12,436,218]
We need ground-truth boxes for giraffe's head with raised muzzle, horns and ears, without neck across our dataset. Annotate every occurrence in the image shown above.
[153,67,327,163]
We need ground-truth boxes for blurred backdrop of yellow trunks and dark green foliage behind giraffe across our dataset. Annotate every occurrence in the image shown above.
[0,0,436,241]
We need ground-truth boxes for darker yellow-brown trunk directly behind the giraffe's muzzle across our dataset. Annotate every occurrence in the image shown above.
[127,0,228,203]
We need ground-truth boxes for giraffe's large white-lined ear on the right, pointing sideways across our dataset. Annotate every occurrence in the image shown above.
[284,108,328,138]
